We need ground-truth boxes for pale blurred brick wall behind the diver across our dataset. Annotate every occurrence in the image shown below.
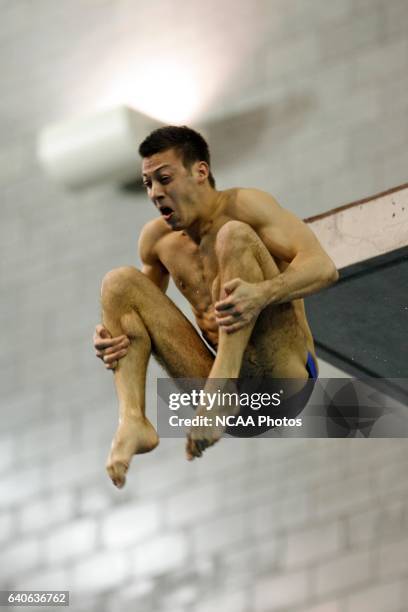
[0,0,408,612]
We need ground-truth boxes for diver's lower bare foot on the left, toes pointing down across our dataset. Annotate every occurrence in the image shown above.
[106,418,159,489]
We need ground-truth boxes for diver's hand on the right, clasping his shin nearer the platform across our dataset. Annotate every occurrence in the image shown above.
[215,278,267,334]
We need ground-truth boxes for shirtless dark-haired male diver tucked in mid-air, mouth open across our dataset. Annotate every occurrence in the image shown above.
[94,126,338,487]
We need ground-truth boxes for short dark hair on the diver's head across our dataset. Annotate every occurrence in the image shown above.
[139,125,215,187]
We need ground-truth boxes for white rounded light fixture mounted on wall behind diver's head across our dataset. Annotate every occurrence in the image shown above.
[37,106,161,188]
